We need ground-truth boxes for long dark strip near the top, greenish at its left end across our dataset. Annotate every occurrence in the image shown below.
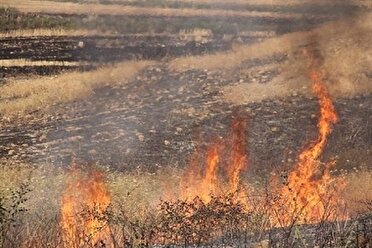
[0,8,334,34]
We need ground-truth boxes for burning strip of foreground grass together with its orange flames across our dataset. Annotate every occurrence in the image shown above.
[3,68,372,248]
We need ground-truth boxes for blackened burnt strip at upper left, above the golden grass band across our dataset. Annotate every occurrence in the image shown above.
[0,35,231,77]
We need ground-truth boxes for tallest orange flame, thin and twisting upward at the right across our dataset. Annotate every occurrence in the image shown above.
[281,49,343,223]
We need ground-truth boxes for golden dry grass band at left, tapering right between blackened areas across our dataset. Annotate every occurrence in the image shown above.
[0,61,153,115]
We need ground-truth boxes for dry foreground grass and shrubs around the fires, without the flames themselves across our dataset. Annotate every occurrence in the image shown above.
[0,162,372,248]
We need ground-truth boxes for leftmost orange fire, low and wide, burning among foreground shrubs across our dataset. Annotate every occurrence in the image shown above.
[61,171,111,248]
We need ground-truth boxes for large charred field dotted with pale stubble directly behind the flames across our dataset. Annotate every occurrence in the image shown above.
[0,63,372,174]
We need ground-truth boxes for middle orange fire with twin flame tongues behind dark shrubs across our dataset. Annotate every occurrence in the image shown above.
[180,117,247,202]
